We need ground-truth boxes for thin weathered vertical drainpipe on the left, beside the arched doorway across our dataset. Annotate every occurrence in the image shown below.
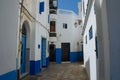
[17,0,24,80]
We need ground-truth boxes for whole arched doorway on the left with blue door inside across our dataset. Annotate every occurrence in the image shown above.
[20,21,30,77]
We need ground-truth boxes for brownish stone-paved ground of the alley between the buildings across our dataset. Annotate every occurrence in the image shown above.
[24,63,89,80]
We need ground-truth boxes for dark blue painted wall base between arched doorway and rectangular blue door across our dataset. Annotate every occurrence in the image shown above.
[30,60,41,75]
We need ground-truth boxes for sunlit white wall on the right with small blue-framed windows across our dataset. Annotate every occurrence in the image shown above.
[81,0,97,80]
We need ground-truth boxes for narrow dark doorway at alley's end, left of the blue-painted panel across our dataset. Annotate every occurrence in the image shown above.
[49,43,56,62]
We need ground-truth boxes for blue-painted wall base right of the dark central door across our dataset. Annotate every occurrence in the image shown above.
[70,51,83,62]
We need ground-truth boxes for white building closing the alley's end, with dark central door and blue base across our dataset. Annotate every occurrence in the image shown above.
[50,9,83,63]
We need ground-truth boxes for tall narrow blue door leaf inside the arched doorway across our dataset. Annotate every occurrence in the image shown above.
[21,35,26,74]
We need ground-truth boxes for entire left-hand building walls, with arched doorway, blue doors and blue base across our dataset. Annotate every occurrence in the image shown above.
[0,0,49,80]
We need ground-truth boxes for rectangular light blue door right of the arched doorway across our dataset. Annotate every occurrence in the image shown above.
[41,38,46,67]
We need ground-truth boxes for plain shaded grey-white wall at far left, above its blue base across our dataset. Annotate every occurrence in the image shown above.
[0,0,19,75]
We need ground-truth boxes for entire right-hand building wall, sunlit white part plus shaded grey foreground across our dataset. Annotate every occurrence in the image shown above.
[82,0,120,80]
